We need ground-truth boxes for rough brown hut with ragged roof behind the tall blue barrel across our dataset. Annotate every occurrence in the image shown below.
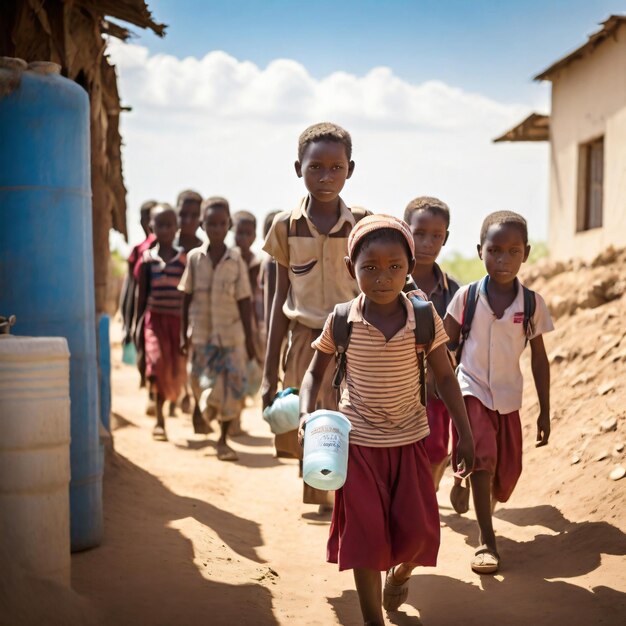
[0,0,165,314]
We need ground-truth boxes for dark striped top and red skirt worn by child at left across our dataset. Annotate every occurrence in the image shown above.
[141,246,187,401]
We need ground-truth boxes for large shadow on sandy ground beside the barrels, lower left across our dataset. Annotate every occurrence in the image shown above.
[72,453,277,626]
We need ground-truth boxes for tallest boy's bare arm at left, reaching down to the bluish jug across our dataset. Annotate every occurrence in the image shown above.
[261,263,289,408]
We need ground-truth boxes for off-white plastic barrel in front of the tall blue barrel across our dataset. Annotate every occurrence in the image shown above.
[0,335,70,585]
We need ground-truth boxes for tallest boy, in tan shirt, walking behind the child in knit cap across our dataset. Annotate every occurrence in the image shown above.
[261,123,366,506]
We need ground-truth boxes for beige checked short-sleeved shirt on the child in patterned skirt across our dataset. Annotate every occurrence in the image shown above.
[178,242,252,348]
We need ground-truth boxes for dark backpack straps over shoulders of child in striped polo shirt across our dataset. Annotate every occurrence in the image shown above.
[333,296,435,406]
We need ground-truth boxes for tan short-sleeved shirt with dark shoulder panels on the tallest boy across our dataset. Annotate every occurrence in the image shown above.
[263,196,358,328]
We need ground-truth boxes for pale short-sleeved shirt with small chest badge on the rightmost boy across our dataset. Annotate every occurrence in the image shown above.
[447,278,554,414]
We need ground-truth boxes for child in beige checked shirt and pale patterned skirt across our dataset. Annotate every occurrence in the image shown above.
[179,197,255,461]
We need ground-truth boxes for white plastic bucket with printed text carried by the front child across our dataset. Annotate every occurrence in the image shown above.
[302,409,352,491]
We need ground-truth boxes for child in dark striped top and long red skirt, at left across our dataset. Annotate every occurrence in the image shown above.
[137,204,186,441]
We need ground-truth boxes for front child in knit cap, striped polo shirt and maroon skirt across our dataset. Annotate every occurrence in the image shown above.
[300,215,473,626]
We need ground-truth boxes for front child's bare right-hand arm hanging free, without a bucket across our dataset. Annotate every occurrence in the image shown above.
[426,342,474,477]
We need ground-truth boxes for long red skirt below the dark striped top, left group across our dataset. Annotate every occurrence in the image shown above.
[144,310,187,402]
